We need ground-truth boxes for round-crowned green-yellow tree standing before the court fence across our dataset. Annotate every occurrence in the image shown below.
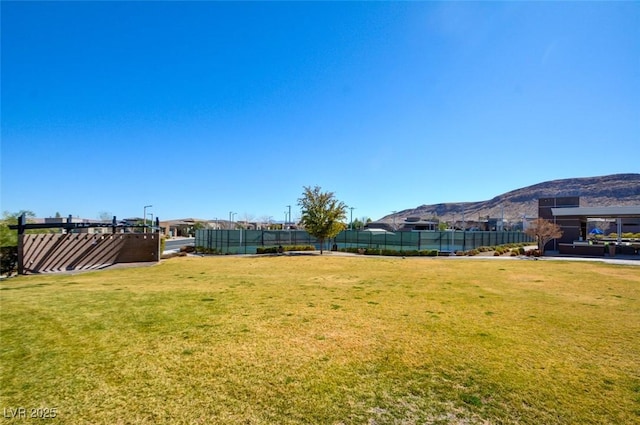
[298,186,347,254]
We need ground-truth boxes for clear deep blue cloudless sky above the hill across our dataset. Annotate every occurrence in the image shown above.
[0,1,640,220]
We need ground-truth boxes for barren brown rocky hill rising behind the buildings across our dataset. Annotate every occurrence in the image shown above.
[380,174,640,222]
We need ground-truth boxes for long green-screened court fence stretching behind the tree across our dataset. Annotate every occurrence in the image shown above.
[195,229,533,254]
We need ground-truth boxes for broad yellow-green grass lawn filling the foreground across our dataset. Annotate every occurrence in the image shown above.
[0,255,640,425]
